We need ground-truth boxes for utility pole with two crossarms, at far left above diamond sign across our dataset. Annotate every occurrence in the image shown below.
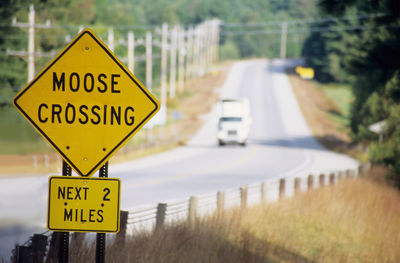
[7,5,50,82]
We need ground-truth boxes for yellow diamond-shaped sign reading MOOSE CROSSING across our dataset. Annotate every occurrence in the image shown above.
[13,29,160,176]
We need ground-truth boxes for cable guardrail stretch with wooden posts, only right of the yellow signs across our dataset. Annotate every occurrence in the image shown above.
[127,163,371,232]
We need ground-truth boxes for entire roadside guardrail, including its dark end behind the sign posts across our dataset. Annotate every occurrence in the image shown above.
[11,163,371,263]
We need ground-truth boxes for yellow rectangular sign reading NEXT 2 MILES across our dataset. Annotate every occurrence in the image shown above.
[47,176,121,233]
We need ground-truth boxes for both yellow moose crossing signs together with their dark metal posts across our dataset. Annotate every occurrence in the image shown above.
[13,29,160,262]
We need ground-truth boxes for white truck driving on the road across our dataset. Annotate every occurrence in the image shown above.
[217,99,251,146]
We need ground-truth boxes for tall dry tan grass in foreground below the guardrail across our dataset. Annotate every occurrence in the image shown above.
[71,175,400,263]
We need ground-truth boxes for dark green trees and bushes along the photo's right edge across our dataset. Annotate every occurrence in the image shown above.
[303,0,400,186]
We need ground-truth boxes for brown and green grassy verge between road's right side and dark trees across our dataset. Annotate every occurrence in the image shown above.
[287,68,360,159]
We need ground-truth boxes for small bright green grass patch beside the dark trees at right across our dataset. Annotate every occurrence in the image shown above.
[317,83,354,126]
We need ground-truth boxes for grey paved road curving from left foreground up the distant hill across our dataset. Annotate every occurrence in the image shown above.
[0,60,357,258]
